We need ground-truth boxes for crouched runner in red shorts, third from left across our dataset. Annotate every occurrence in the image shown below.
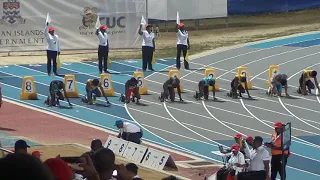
[120,77,141,104]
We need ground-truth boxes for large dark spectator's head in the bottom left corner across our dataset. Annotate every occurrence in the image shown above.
[0,153,56,180]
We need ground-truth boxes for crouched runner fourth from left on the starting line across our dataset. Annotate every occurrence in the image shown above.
[159,77,183,102]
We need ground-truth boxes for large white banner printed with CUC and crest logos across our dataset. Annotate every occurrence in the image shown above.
[0,0,146,51]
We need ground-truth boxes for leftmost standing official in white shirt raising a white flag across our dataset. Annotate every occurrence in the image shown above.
[44,22,60,76]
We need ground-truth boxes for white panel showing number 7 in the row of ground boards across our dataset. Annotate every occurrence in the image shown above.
[123,142,148,163]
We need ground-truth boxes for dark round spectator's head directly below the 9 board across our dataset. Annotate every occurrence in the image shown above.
[93,148,116,173]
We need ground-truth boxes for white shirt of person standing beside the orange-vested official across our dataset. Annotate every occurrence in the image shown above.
[249,146,271,171]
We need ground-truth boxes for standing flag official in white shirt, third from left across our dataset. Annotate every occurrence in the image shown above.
[138,24,156,71]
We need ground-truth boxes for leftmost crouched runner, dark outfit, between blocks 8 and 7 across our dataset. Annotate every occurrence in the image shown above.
[44,80,72,107]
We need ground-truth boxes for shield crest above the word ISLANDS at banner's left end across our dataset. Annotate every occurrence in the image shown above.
[0,0,26,24]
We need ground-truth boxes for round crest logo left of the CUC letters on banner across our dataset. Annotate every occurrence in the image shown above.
[79,7,99,30]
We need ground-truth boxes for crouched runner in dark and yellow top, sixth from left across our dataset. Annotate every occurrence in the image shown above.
[227,75,251,99]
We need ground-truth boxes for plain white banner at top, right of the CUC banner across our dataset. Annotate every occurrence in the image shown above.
[148,0,228,21]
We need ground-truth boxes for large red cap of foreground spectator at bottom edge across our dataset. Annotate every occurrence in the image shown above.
[44,158,74,180]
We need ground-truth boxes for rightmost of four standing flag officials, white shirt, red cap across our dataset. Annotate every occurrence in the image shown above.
[176,23,190,69]
